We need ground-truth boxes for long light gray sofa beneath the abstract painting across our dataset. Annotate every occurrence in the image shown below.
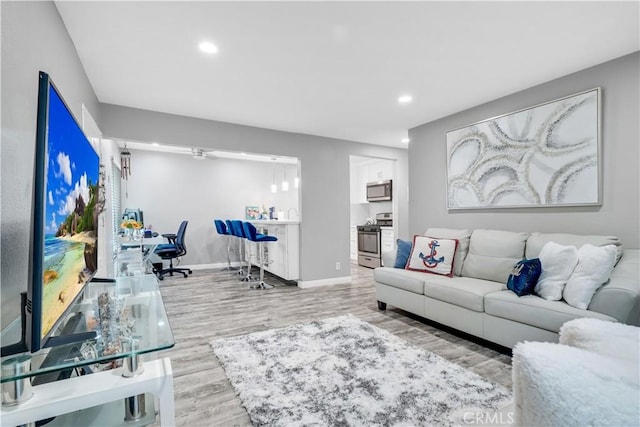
[374,228,640,347]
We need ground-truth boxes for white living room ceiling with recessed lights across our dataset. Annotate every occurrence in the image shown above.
[56,1,640,147]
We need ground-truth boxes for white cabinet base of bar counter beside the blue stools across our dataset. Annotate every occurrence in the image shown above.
[251,220,300,280]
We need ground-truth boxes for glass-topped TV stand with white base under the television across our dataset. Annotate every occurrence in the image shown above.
[0,275,175,426]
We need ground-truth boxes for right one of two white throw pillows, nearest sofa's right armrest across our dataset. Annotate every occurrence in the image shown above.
[562,243,617,310]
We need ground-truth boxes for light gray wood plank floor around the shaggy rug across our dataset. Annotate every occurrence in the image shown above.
[154,265,511,427]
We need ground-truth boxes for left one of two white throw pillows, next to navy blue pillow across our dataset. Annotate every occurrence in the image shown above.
[534,242,578,301]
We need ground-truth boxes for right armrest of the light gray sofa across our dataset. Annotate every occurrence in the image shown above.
[588,249,640,326]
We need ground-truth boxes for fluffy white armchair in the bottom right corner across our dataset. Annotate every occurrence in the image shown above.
[513,318,640,427]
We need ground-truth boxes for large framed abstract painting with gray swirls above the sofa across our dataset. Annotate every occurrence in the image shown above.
[446,88,602,210]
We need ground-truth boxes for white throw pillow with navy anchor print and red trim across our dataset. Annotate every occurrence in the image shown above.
[406,235,458,277]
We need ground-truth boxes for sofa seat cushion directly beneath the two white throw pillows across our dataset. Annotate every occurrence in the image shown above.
[484,291,615,332]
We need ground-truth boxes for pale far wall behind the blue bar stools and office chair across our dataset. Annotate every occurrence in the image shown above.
[121,150,299,265]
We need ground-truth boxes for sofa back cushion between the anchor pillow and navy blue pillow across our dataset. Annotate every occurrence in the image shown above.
[462,230,528,284]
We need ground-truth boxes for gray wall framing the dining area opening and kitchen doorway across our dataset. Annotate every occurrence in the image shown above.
[101,104,408,281]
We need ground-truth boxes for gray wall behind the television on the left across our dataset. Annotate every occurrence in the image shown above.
[0,1,100,327]
